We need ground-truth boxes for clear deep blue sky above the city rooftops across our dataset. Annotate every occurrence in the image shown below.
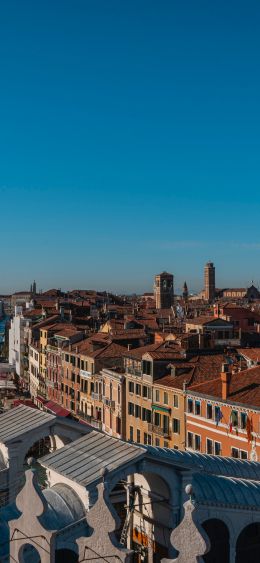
[0,0,260,292]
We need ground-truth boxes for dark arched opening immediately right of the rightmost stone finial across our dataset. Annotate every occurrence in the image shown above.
[202,518,229,563]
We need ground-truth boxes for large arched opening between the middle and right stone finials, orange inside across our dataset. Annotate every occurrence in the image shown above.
[110,473,171,563]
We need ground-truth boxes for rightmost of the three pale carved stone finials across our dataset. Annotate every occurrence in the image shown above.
[162,485,210,563]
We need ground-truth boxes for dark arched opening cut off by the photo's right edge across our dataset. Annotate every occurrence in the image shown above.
[236,522,260,563]
